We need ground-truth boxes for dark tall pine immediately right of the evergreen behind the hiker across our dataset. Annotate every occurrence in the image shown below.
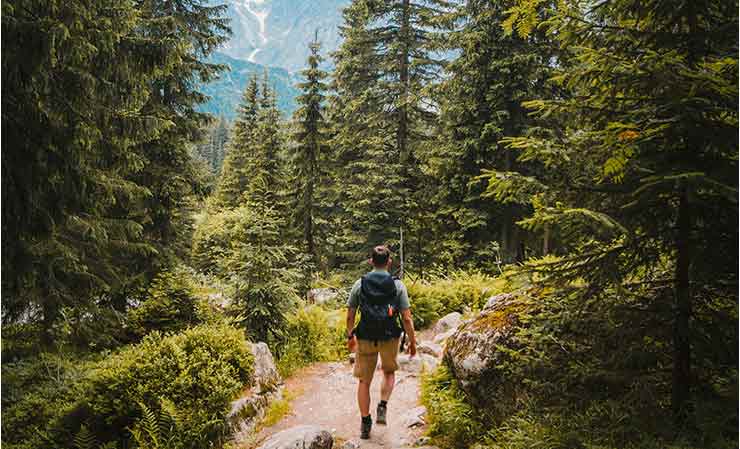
[425,0,563,264]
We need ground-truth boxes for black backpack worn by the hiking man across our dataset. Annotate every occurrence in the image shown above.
[356,271,403,341]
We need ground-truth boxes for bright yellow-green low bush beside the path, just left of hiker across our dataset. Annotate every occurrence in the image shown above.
[277,305,348,377]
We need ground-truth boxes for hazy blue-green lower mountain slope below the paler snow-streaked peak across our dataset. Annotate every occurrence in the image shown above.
[199,52,299,121]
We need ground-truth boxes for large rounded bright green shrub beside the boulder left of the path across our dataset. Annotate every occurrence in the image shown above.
[80,325,253,447]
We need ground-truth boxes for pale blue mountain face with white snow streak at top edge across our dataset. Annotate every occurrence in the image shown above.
[214,0,350,72]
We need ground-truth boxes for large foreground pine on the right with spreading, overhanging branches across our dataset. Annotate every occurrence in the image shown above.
[489,0,738,423]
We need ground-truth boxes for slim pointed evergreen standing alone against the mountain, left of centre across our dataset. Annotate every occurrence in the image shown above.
[291,36,329,261]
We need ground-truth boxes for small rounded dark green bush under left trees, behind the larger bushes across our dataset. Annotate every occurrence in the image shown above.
[128,268,201,338]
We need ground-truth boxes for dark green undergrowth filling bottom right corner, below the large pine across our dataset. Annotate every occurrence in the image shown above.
[422,276,737,449]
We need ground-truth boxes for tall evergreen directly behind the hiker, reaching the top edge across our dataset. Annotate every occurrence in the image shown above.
[332,0,448,268]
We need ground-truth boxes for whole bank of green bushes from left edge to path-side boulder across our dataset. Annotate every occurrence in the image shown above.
[2,325,253,449]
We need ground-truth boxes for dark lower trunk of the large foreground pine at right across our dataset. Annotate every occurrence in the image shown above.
[671,186,691,423]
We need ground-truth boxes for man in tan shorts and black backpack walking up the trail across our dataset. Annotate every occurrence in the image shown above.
[347,245,416,439]
